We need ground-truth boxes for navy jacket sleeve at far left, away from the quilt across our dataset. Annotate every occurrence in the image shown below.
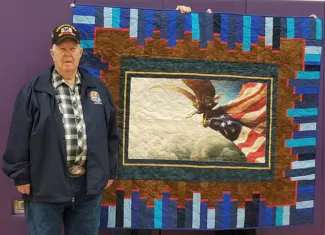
[2,83,33,186]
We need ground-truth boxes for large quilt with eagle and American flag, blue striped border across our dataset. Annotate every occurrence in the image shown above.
[73,4,323,230]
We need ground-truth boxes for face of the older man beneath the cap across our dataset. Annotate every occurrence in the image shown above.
[51,38,82,72]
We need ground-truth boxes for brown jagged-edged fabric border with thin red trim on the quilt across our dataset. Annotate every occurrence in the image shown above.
[94,28,305,206]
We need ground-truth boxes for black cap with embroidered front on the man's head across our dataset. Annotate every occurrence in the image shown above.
[52,24,80,45]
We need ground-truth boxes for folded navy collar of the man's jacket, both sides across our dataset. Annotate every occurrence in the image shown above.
[35,66,97,95]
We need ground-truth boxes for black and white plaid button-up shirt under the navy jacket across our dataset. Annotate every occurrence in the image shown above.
[52,70,87,166]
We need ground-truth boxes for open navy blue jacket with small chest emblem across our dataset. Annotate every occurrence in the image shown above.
[2,66,119,202]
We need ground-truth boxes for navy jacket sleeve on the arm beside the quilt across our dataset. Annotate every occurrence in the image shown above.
[103,84,119,179]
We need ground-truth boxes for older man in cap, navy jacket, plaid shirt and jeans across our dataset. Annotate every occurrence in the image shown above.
[2,24,119,235]
